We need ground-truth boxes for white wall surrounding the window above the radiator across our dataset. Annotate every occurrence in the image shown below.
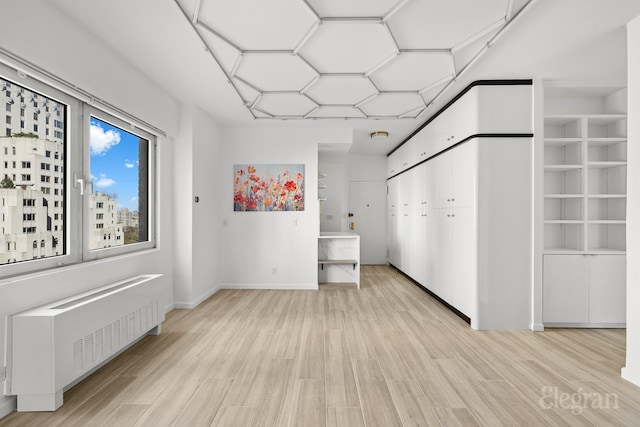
[0,1,179,417]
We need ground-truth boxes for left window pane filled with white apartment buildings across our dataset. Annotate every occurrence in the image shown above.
[0,73,69,265]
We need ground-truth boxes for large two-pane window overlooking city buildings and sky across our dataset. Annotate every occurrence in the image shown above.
[0,66,155,278]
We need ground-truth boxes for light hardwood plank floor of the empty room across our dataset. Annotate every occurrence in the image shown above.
[0,266,640,427]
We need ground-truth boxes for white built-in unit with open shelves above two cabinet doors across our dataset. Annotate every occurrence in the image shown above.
[542,86,627,327]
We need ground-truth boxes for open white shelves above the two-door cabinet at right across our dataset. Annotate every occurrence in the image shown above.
[544,88,627,254]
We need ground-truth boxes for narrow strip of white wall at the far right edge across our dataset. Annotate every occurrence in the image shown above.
[622,17,640,386]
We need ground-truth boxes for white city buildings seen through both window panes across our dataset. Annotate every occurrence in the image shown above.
[0,79,139,265]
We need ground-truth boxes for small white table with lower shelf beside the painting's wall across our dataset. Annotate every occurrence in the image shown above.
[318,232,360,289]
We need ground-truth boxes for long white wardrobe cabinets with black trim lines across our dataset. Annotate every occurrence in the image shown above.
[387,84,533,329]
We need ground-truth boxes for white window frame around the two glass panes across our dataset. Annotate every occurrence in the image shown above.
[0,61,159,283]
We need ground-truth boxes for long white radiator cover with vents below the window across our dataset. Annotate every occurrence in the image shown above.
[8,274,164,411]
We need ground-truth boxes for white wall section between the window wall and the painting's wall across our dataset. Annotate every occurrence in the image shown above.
[173,105,220,308]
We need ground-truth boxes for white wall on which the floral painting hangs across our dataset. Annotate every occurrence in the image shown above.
[218,127,351,289]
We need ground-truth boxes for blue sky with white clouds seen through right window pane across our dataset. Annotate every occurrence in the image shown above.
[90,117,138,211]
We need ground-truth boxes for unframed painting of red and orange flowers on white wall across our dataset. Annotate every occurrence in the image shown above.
[233,164,304,212]
